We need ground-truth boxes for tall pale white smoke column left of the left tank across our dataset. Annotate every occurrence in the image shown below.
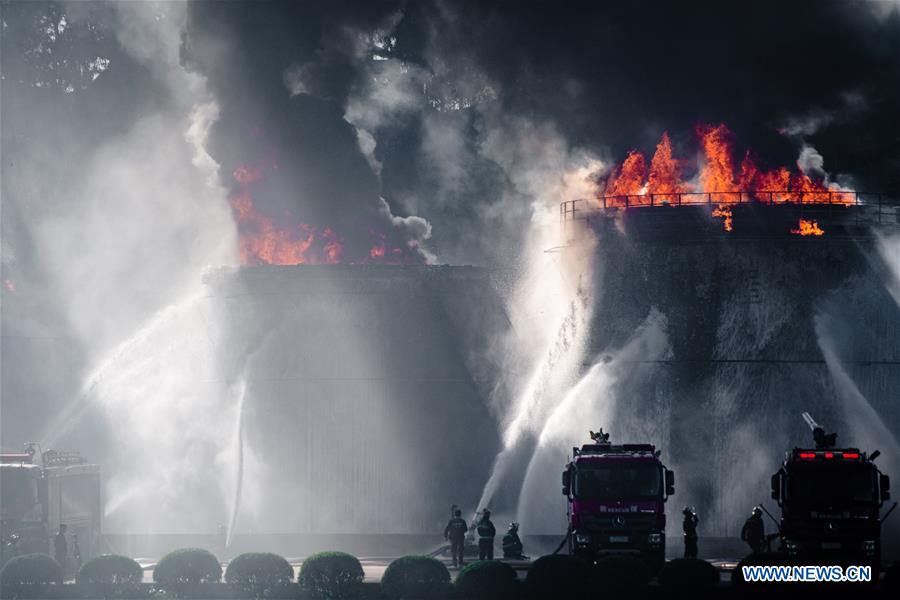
[4,2,243,532]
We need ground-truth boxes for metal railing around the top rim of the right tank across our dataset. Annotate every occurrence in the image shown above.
[559,190,900,237]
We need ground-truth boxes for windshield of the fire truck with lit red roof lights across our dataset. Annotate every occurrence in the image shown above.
[785,463,878,509]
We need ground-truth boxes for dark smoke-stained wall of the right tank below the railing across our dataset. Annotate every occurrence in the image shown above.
[540,194,900,564]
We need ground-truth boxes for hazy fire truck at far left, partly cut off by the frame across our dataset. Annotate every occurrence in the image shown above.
[0,444,101,560]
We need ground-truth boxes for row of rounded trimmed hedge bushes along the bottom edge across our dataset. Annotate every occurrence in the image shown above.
[0,548,897,600]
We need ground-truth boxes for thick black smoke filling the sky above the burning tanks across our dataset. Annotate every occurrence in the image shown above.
[184,0,900,264]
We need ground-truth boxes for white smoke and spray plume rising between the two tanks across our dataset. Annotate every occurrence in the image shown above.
[345,5,605,508]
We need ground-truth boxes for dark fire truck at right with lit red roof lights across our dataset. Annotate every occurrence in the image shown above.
[772,413,897,571]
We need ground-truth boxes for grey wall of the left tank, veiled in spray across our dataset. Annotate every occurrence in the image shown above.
[207,265,508,534]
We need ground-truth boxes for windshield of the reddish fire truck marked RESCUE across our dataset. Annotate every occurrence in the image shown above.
[574,463,662,500]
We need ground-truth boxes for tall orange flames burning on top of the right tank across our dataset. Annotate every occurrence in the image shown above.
[603,124,856,235]
